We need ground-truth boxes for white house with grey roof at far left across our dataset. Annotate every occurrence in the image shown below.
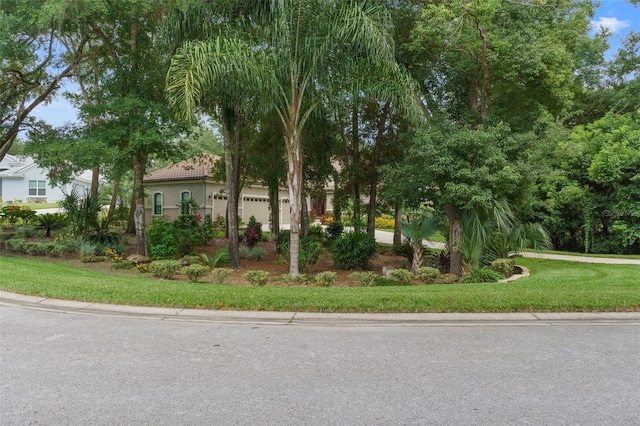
[0,155,91,203]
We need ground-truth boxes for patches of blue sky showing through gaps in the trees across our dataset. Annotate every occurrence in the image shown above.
[33,0,640,127]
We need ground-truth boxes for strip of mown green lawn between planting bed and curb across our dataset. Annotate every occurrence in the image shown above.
[0,257,640,312]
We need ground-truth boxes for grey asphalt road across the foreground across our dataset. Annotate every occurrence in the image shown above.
[0,305,640,425]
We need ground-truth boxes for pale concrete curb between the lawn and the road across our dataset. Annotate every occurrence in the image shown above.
[0,291,640,327]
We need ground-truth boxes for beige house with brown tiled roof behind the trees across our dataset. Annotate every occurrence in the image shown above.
[144,154,338,225]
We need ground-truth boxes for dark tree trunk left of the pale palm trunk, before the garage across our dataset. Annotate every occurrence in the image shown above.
[222,116,240,269]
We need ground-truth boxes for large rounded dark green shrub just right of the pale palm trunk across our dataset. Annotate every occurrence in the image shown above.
[330,232,378,269]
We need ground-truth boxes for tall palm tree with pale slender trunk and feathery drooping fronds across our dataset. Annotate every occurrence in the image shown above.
[167,0,420,275]
